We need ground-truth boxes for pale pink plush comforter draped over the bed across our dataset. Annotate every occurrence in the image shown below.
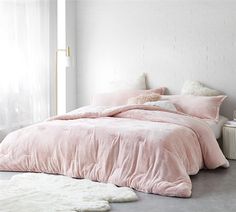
[0,105,229,197]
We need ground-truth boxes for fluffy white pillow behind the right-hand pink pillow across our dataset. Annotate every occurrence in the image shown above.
[181,80,221,96]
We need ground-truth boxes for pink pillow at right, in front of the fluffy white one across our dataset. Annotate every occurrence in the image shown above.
[161,95,226,121]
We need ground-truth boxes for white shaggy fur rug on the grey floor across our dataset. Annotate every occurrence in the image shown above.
[0,173,137,212]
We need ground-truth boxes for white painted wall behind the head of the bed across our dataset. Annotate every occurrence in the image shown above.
[76,0,236,117]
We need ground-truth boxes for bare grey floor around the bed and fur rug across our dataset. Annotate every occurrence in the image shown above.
[0,160,236,212]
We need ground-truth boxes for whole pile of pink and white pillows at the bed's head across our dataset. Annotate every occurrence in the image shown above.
[92,74,226,121]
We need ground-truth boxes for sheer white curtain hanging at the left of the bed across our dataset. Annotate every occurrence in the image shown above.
[0,0,50,140]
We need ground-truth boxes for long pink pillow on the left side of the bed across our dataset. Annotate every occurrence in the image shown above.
[92,87,165,106]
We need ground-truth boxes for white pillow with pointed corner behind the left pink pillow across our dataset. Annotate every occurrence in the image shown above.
[106,73,147,92]
